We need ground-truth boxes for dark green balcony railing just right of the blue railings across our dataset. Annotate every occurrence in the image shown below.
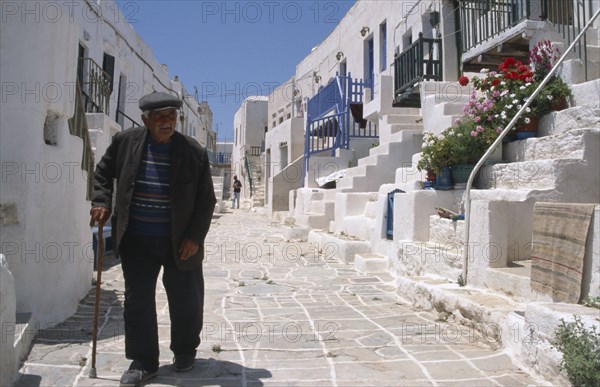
[394,33,442,102]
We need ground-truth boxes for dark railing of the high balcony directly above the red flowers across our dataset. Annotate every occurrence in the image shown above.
[460,0,528,53]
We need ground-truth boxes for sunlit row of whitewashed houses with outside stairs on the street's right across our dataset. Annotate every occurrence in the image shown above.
[265,0,600,384]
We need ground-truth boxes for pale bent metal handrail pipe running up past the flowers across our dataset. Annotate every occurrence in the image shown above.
[462,9,600,285]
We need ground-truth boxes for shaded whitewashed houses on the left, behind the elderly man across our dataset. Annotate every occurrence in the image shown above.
[0,0,216,386]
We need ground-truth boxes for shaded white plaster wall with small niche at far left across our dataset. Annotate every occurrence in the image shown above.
[0,6,93,326]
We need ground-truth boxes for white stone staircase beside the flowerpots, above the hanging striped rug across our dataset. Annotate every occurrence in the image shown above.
[472,97,600,300]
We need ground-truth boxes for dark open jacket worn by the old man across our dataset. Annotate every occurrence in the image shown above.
[92,127,216,270]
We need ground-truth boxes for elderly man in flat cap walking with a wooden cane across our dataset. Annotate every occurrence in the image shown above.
[90,92,216,386]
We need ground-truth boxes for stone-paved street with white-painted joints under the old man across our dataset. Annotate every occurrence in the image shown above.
[17,210,540,386]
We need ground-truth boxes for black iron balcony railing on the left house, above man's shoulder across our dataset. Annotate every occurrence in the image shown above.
[78,58,112,113]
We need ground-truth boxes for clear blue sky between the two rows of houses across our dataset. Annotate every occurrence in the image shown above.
[117,0,354,141]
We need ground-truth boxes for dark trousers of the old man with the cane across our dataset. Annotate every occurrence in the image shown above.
[120,233,204,372]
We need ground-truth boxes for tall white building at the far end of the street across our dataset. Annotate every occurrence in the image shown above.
[229,96,268,207]
